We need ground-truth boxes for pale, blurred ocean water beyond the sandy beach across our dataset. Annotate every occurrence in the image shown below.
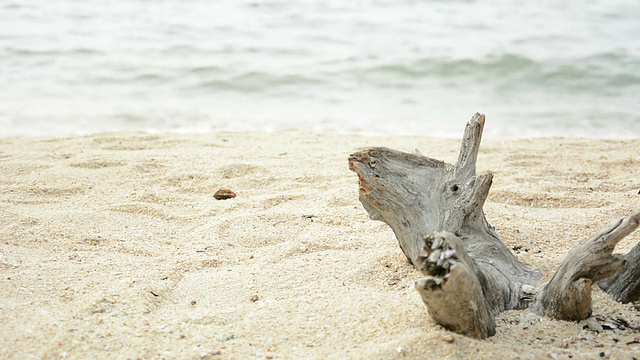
[0,0,640,138]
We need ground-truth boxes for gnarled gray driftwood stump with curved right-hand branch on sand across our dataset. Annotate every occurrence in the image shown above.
[349,114,640,338]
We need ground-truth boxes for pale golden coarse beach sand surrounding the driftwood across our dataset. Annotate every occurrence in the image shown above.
[0,131,640,359]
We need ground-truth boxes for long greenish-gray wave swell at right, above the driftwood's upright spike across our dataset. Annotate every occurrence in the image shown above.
[363,53,640,92]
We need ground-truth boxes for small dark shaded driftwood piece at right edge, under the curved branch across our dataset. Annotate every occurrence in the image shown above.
[599,244,640,304]
